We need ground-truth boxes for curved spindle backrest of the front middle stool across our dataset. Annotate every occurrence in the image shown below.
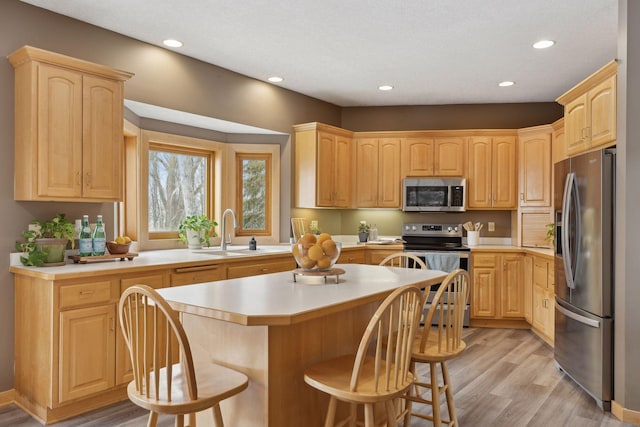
[350,285,423,392]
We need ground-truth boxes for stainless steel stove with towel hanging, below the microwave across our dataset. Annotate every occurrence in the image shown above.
[402,223,471,326]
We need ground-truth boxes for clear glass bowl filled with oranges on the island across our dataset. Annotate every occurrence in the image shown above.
[291,233,342,271]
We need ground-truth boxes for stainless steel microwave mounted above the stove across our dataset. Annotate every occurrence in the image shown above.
[402,177,466,212]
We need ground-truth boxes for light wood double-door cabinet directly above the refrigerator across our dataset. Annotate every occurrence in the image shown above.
[557,61,617,156]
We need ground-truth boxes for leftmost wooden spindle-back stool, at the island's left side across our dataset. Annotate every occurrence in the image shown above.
[119,285,249,427]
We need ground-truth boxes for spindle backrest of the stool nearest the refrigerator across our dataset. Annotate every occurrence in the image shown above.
[420,269,469,353]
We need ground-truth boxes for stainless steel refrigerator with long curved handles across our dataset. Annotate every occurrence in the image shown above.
[554,149,616,410]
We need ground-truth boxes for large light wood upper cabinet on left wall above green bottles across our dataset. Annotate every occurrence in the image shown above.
[9,46,132,202]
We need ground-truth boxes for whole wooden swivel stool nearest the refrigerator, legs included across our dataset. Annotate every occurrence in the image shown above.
[404,269,469,427]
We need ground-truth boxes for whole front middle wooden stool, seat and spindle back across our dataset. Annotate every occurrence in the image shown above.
[304,286,423,427]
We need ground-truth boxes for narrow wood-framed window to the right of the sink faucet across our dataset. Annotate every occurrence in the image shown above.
[236,153,273,236]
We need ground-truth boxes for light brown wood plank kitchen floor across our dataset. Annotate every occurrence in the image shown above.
[0,328,631,427]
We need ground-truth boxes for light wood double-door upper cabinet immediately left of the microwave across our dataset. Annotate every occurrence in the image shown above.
[355,138,401,208]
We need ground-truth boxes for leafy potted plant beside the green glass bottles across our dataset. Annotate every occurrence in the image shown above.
[16,214,76,267]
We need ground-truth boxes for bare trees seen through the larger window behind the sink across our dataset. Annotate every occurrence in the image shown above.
[149,150,208,233]
